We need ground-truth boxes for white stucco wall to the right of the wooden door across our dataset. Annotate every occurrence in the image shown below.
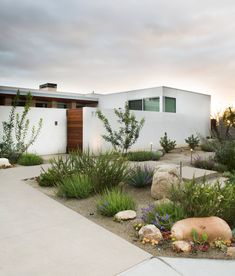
[83,107,210,151]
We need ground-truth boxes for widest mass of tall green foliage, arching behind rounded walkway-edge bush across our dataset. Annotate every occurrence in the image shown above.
[39,150,128,193]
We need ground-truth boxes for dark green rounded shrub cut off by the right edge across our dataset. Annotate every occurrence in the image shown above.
[215,140,235,171]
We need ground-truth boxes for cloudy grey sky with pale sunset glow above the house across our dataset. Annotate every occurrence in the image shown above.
[0,0,235,113]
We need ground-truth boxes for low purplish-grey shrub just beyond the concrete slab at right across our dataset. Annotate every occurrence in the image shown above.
[193,156,227,172]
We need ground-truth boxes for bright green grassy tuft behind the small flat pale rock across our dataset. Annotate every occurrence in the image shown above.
[97,187,135,217]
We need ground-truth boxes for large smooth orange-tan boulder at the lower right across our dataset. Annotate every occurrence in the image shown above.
[171,217,232,242]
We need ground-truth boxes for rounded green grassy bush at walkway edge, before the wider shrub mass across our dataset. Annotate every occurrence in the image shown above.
[57,174,93,198]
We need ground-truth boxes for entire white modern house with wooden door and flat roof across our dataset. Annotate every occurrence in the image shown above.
[0,84,211,154]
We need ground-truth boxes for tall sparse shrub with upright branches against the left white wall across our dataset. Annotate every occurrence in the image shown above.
[0,90,42,163]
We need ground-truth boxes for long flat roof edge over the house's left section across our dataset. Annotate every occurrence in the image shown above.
[0,86,99,102]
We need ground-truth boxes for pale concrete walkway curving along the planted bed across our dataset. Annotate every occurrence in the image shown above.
[0,166,235,276]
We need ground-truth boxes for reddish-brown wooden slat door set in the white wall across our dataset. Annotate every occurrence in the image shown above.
[67,108,83,152]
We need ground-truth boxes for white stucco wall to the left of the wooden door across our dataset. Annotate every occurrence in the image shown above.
[0,106,67,155]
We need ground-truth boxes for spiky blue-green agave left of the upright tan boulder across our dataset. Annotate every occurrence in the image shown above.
[127,166,154,188]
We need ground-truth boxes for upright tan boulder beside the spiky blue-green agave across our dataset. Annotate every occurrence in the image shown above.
[151,164,180,199]
